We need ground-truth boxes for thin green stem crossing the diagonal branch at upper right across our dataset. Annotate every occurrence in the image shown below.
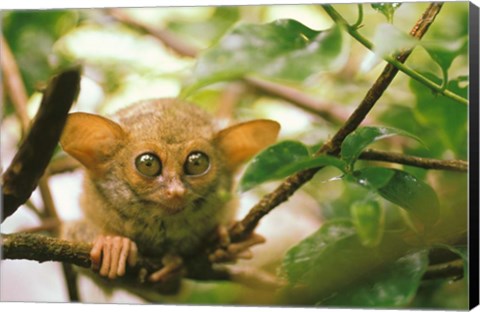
[322,4,468,105]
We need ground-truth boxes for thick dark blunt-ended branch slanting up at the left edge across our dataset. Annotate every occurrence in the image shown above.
[1,68,80,221]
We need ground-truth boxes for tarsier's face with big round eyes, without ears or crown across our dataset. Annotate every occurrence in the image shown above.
[121,132,224,214]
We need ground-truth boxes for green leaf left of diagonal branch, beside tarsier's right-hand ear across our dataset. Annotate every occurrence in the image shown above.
[240,141,345,191]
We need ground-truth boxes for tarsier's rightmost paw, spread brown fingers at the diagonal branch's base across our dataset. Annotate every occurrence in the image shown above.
[209,225,265,263]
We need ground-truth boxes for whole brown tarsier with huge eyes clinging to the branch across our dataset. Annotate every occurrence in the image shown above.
[60,99,280,282]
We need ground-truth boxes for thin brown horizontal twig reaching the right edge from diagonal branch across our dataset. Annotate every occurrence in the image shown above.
[360,149,468,172]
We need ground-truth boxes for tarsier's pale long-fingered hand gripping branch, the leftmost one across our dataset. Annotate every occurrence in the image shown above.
[90,235,138,279]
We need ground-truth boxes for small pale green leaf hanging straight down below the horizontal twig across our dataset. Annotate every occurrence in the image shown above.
[350,199,385,247]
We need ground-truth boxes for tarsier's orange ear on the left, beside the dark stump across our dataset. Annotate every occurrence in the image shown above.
[60,113,126,173]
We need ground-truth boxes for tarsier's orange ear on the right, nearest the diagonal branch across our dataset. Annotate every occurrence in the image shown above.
[216,119,280,170]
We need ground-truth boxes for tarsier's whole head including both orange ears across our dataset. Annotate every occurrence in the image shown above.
[61,99,279,215]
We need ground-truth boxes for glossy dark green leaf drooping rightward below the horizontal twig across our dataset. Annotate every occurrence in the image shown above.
[346,167,440,225]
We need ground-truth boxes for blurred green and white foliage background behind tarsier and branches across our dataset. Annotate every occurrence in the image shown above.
[1,2,468,309]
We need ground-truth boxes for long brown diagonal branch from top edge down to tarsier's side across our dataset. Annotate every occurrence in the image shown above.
[230,3,442,240]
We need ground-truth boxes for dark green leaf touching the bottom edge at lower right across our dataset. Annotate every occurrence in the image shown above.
[321,251,428,308]
